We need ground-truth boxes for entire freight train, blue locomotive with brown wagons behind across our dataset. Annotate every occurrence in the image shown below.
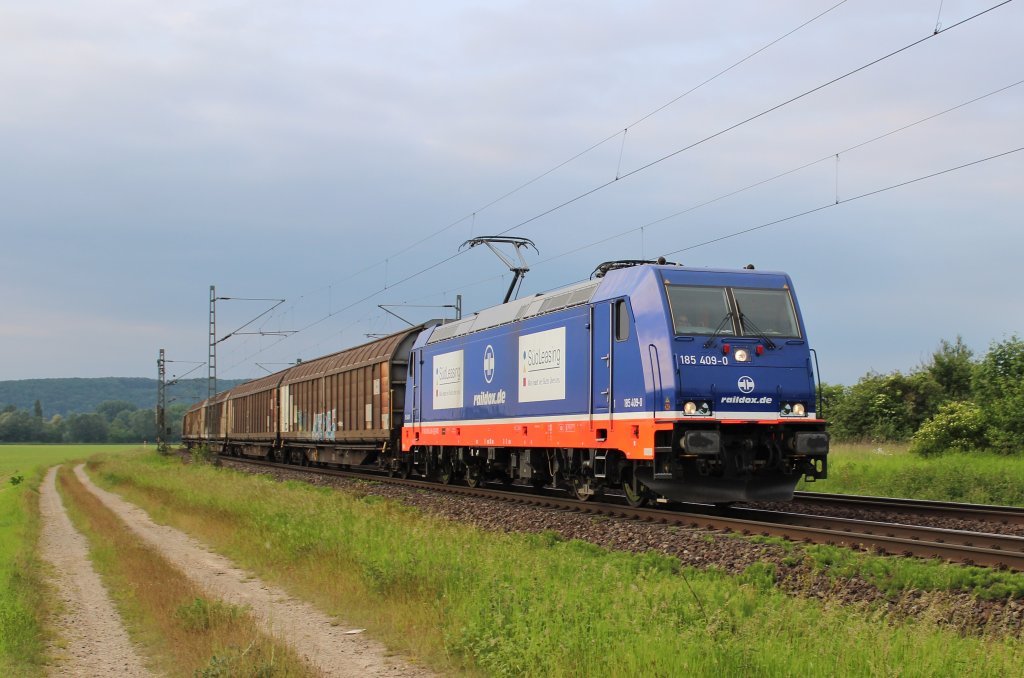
[182,261,828,506]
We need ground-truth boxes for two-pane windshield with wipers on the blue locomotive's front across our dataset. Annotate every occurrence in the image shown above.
[666,285,800,337]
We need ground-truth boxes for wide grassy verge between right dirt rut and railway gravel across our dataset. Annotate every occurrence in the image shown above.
[93,455,1024,676]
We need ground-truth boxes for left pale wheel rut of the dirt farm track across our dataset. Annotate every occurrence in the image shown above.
[39,466,151,678]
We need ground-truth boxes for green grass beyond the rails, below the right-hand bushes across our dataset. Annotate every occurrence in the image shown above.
[798,443,1024,506]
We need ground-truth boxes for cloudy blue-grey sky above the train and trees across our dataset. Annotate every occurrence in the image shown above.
[0,0,1024,396]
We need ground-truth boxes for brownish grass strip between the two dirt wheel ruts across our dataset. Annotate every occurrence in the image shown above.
[51,468,315,676]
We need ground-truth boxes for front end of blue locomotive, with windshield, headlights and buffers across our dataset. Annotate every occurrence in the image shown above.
[626,267,828,503]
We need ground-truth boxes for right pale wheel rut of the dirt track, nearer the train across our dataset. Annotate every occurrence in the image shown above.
[75,466,431,678]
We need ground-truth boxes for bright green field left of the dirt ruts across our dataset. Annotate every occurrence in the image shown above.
[0,444,132,676]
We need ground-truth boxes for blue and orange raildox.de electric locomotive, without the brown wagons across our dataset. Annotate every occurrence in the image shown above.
[397,262,828,505]
